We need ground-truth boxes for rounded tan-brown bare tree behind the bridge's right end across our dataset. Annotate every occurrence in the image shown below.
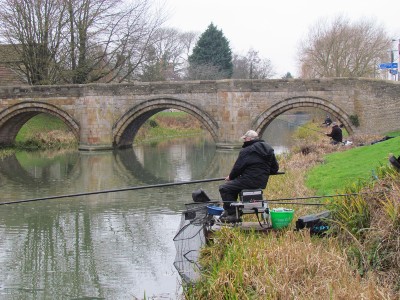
[298,16,390,78]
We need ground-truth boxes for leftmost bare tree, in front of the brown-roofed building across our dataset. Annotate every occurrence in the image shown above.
[0,0,66,84]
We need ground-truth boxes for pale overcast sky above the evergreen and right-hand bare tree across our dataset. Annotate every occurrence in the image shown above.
[165,0,400,78]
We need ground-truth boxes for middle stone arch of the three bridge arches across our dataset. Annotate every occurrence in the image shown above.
[113,98,218,148]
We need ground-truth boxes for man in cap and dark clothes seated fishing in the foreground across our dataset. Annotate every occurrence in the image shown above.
[219,130,279,222]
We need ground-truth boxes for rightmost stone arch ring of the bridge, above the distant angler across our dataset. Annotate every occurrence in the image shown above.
[252,96,355,135]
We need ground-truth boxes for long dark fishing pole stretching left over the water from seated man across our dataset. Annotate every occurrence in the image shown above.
[0,177,225,205]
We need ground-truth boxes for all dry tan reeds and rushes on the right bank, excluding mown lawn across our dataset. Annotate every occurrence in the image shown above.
[184,132,400,300]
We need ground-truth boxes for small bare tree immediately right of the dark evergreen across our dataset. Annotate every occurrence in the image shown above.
[232,49,275,79]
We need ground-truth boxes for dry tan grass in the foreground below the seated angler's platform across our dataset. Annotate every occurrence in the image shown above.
[186,229,393,300]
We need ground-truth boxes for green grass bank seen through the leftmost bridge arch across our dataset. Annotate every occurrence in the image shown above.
[15,114,69,142]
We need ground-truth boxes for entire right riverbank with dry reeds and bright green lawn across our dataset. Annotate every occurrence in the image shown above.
[185,131,400,299]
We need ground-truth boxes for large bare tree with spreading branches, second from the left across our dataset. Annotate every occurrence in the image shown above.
[63,0,165,83]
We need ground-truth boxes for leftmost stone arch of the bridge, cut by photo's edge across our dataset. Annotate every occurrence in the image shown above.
[0,101,79,145]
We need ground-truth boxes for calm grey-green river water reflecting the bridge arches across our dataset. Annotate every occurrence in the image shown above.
[0,114,310,299]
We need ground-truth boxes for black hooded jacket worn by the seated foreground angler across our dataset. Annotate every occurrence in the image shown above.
[229,140,279,189]
